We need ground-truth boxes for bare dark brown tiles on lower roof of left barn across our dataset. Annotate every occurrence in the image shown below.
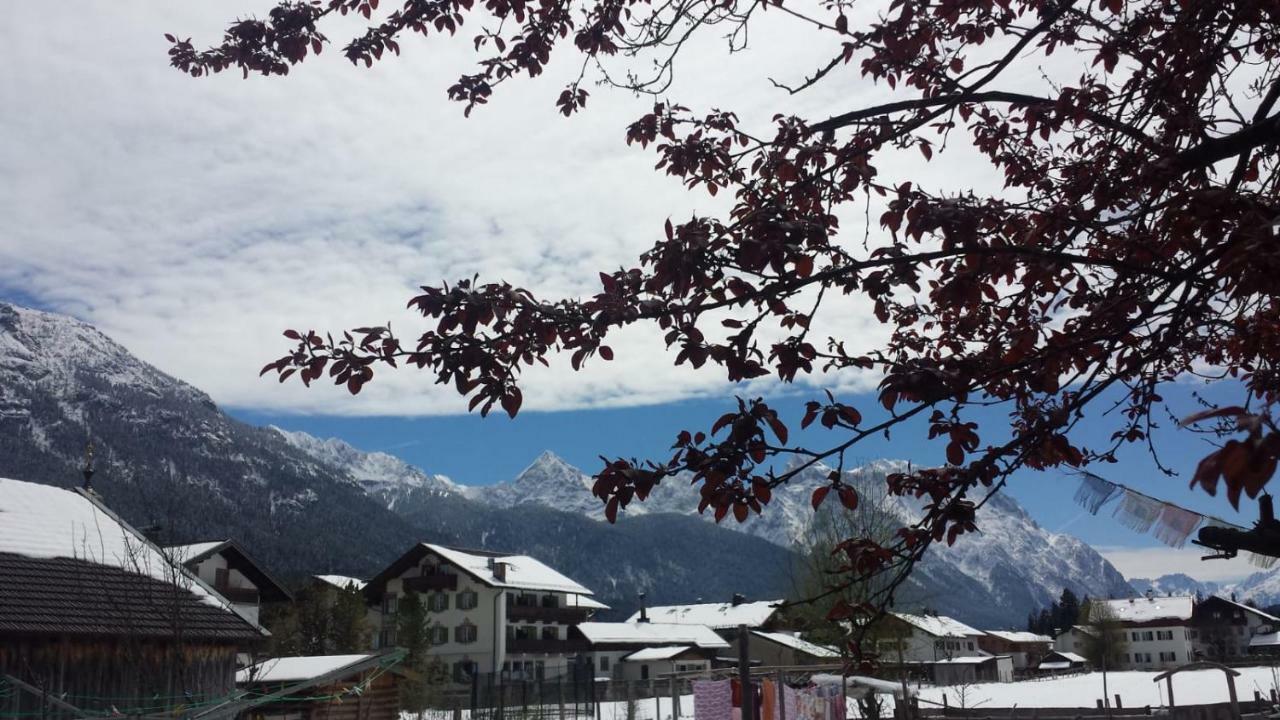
[0,552,262,642]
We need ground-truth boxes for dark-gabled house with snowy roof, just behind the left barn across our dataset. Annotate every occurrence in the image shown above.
[164,539,293,623]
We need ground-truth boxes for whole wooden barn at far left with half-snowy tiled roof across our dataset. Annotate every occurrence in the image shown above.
[0,478,266,715]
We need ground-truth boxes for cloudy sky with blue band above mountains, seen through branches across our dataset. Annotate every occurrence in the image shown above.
[0,0,1251,579]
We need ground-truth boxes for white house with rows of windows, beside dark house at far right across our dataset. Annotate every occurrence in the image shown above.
[1096,593,1196,670]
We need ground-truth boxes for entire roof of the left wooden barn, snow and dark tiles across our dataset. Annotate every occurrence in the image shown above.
[0,478,266,642]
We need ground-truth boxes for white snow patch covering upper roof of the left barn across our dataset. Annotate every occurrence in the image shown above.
[0,478,235,607]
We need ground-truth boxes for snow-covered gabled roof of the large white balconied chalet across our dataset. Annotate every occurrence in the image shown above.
[365,542,593,601]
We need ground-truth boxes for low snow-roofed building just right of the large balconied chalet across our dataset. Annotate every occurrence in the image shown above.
[570,621,730,680]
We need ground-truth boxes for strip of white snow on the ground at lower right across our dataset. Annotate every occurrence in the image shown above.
[919,667,1280,707]
